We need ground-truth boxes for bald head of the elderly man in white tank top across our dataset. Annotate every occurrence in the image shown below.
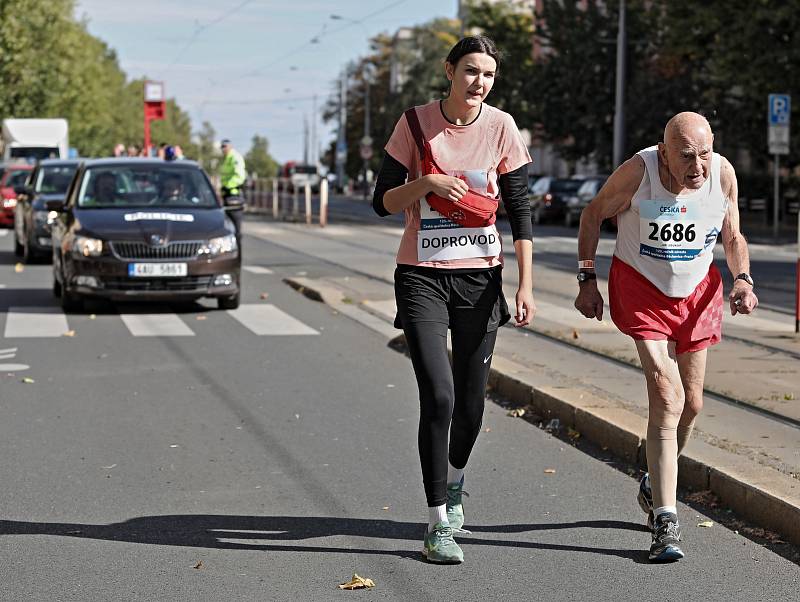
[658,111,714,193]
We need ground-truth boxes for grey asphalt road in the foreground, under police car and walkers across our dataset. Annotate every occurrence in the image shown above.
[0,226,800,601]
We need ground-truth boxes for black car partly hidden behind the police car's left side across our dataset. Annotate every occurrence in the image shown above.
[14,159,78,263]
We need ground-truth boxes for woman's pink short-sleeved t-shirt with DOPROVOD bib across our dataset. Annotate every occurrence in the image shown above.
[386,100,531,269]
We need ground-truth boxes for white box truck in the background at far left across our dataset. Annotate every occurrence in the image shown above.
[0,119,69,161]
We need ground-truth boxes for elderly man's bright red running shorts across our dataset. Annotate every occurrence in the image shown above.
[608,256,724,353]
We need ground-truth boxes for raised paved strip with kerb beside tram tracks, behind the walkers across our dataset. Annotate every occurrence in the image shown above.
[245,222,800,543]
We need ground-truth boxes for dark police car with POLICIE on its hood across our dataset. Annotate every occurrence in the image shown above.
[47,158,241,311]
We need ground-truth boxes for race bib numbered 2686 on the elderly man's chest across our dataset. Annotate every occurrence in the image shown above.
[639,199,700,261]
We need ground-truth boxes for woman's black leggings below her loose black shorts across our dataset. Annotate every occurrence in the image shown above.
[403,322,497,506]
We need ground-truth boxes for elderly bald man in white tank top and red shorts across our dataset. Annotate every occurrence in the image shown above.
[575,112,758,562]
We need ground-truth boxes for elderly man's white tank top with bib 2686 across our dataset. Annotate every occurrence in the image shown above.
[614,146,728,298]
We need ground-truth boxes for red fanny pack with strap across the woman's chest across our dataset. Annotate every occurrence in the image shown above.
[405,108,497,228]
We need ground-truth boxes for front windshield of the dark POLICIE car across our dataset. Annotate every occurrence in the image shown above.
[78,165,219,209]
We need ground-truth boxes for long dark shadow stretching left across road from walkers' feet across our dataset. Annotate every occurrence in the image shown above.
[0,514,647,563]
